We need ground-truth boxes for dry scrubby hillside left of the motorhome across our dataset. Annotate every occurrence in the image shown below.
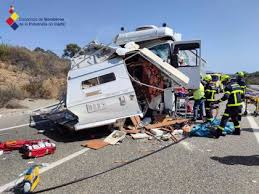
[0,44,69,107]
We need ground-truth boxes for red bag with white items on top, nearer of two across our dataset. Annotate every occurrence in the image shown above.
[22,142,56,158]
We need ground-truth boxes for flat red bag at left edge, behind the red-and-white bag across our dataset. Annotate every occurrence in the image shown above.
[0,139,49,151]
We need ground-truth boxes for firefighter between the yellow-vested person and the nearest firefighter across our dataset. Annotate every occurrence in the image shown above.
[203,75,217,122]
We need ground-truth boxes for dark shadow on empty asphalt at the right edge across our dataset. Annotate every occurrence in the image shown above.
[211,155,259,166]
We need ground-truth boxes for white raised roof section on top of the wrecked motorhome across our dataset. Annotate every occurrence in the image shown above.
[114,25,184,45]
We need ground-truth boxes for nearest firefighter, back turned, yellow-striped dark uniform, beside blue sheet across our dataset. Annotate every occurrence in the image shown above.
[215,75,243,138]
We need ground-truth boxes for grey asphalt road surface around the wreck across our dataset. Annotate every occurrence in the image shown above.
[0,98,259,194]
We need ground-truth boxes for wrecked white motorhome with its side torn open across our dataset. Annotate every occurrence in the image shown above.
[49,23,207,130]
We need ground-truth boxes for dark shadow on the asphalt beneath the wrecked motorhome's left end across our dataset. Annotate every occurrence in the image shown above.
[31,117,111,143]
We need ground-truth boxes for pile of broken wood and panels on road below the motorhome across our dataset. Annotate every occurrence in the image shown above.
[82,115,193,150]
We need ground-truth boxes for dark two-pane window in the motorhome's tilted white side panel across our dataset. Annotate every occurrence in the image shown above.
[82,73,116,89]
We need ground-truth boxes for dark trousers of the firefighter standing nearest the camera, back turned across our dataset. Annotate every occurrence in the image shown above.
[218,106,242,131]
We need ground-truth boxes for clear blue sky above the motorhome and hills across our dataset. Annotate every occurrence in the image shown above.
[0,0,259,73]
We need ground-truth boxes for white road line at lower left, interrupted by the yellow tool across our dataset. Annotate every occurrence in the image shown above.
[0,148,89,193]
